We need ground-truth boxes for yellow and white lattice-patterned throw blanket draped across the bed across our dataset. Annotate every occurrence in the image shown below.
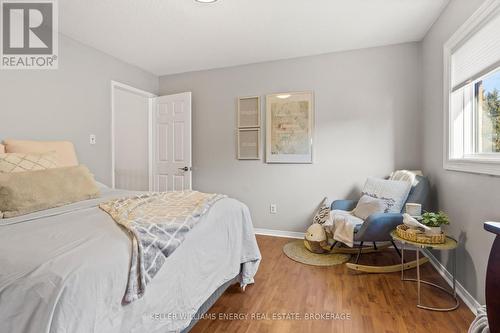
[99,191,225,304]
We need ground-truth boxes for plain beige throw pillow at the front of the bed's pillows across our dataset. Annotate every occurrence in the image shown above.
[0,165,100,218]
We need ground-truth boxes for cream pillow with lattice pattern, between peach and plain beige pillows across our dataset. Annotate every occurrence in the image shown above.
[0,152,58,172]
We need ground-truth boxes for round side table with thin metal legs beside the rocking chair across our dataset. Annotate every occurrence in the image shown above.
[391,230,460,312]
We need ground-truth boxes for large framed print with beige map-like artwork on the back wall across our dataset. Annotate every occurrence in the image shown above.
[266,92,314,163]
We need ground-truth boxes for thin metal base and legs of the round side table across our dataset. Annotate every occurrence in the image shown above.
[401,242,460,312]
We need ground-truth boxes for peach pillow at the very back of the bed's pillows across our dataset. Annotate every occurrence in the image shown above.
[3,140,78,167]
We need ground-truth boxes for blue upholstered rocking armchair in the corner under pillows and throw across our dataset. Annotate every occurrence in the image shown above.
[331,176,430,268]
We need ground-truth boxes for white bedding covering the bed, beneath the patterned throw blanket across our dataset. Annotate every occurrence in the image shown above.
[0,187,260,333]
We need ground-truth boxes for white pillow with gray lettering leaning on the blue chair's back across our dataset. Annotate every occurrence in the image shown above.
[362,177,412,213]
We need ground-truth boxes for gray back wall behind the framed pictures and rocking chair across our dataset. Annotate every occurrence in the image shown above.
[160,43,421,232]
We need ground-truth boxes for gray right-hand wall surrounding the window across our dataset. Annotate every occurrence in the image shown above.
[422,0,500,303]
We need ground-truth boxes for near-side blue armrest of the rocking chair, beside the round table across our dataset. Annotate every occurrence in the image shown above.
[354,213,403,242]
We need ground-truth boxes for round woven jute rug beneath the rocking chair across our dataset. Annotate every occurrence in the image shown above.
[283,239,351,266]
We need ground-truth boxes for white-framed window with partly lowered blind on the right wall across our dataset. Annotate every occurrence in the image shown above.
[444,0,500,175]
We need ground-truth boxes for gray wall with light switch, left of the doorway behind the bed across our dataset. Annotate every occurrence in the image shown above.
[0,35,159,184]
